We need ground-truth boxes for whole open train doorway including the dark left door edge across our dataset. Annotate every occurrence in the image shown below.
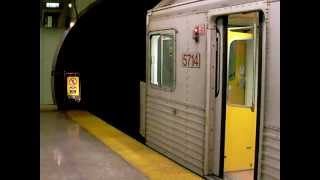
[215,12,261,180]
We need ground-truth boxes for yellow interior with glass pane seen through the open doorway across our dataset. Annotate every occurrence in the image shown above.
[224,13,258,180]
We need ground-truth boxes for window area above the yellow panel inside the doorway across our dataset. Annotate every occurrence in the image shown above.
[227,13,258,106]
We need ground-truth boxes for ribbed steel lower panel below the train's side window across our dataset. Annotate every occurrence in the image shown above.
[146,96,205,174]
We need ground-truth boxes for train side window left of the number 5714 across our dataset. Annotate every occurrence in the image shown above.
[150,31,175,90]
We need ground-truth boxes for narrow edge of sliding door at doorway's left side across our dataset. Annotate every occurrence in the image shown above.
[212,16,228,179]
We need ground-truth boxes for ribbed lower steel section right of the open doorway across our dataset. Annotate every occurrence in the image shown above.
[261,127,280,180]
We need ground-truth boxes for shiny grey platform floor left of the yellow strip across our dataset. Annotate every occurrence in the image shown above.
[40,111,148,180]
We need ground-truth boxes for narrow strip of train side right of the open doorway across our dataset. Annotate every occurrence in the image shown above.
[261,1,280,180]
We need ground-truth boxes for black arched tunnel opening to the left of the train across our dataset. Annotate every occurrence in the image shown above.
[53,0,159,141]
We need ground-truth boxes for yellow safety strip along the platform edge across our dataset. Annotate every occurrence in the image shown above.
[67,111,202,180]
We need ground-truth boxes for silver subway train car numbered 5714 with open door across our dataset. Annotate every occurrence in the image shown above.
[140,0,280,180]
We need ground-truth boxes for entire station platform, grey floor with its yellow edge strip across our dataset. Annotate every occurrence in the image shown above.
[40,111,203,180]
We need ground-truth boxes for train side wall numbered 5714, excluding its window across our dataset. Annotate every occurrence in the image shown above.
[146,13,207,174]
